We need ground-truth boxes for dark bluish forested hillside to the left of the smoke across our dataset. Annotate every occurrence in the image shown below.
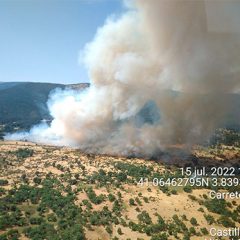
[0,82,65,131]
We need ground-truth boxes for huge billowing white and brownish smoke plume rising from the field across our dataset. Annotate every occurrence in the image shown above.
[5,0,240,156]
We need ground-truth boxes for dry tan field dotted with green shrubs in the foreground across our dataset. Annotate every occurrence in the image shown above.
[0,141,240,240]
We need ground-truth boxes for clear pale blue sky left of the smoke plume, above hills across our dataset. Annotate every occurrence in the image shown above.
[0,0,123,83]
